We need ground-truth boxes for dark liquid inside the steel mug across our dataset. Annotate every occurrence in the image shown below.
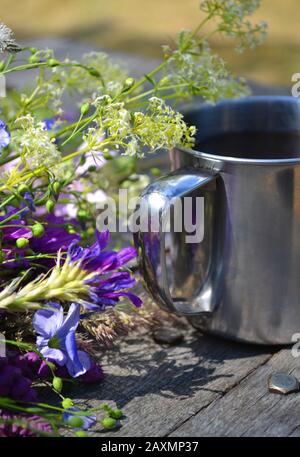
[196,132,300,160]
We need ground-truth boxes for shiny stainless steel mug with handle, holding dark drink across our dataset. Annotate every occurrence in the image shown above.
[135,96,300,344]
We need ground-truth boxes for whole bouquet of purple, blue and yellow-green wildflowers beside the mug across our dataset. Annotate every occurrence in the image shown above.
[0,0,265,436]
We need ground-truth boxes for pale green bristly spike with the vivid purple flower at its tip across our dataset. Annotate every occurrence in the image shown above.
[0,228,141,311]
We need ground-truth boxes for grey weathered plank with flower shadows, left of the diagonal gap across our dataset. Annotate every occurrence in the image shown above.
[73,330,272,436]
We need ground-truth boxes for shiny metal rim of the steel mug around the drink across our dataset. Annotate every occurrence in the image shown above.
[180,95,300,165]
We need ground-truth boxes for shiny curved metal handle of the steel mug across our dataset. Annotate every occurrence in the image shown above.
[134,168,217,315]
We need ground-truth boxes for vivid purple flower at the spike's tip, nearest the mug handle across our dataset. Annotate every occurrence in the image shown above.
[68,231,142,311]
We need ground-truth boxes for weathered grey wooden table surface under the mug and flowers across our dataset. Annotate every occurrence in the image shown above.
[15,39,292,437]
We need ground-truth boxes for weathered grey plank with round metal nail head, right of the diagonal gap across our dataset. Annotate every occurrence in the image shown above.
[171,349,300,437]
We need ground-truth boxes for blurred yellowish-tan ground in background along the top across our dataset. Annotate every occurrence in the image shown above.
[0,0,300,86]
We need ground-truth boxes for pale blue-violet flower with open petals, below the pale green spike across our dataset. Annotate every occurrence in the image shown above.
[33,303,91,378]
